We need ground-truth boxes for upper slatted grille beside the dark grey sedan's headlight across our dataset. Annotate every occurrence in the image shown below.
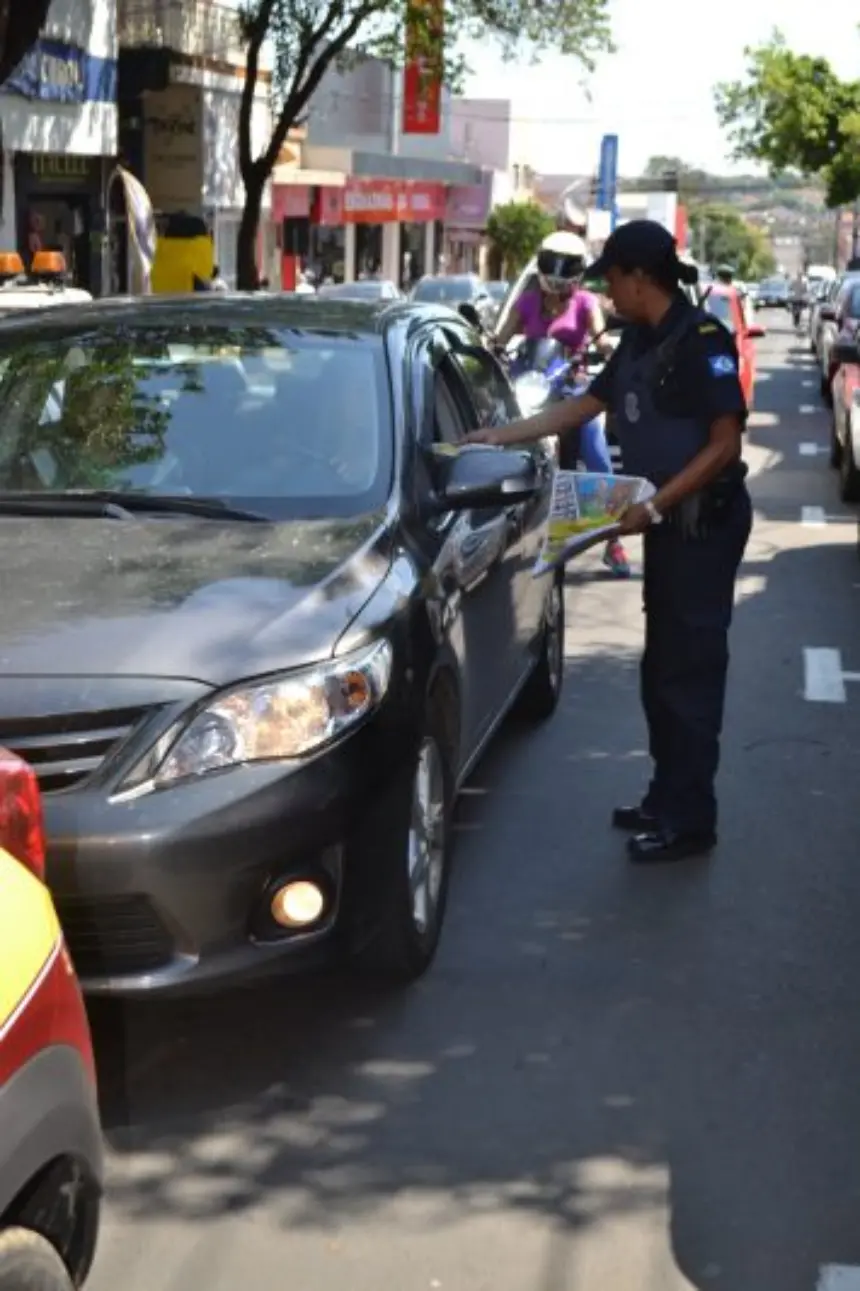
[0,707,147,794]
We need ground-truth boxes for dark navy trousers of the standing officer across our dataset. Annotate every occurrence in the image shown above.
[642,488,752,833]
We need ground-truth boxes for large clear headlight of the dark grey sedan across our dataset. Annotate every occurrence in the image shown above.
[120,640,393,794]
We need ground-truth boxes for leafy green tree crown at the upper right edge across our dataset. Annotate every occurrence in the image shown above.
[714,31,860,207]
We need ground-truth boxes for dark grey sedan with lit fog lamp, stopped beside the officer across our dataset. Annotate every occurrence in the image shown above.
[0,294,564,994]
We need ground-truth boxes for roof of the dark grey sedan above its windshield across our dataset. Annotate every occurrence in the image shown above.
[0,292,457,341]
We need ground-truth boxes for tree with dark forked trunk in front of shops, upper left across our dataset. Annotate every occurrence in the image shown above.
[236,0,612,288]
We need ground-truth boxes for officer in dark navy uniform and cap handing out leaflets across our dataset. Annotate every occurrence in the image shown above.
[470,219,752,862]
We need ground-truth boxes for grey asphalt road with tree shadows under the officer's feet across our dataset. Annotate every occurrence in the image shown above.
[83,315,860,1291]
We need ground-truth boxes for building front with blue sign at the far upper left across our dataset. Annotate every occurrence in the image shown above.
[0,0,118,294]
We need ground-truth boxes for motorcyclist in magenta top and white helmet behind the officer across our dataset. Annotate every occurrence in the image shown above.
[496,230,630,578]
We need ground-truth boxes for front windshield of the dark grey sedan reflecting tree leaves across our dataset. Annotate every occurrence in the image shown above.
[0,319,393,520]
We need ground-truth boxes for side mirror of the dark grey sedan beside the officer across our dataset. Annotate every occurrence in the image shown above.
[428,444,540,511]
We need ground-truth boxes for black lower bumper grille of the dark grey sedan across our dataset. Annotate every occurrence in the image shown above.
[56,896,173,977]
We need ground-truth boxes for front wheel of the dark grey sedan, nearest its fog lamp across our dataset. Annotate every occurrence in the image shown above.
[353,688,455,985]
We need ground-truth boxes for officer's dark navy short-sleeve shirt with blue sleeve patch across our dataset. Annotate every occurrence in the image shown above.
[589,297,746,427]
